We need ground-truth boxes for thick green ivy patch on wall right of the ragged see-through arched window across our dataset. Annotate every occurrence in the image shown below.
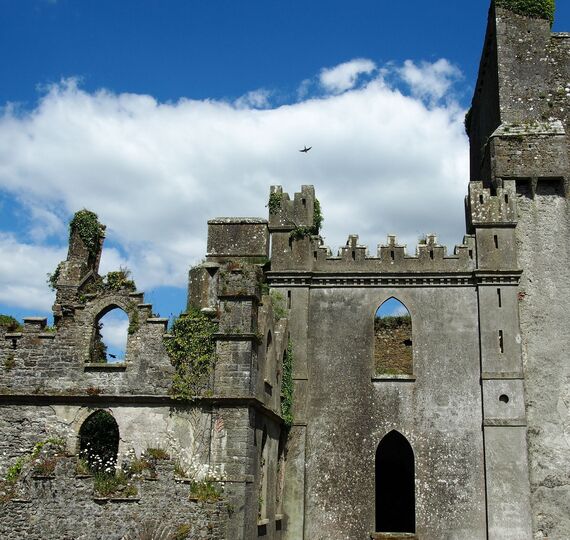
[165,309,218,400]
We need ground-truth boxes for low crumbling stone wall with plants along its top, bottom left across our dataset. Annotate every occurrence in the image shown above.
[0,458,228,540]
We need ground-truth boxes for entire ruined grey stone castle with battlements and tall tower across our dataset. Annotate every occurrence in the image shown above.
[0,0,570,540]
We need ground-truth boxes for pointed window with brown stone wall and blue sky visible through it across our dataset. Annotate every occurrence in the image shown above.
[374,298,413,375]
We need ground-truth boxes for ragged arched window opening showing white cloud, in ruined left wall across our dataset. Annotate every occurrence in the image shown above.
[89,308,129,364]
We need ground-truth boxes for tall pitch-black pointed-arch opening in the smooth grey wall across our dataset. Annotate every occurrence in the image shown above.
[376,431,416,533]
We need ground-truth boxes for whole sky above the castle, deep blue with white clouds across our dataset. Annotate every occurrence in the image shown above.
[0,0,570,352]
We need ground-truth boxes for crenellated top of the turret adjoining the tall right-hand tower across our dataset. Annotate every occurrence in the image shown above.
[465,180,517,227]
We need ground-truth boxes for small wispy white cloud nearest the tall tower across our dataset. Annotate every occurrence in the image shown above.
[398,58,462,104]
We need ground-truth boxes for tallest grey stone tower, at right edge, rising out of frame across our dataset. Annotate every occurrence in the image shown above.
[466,0,570,538]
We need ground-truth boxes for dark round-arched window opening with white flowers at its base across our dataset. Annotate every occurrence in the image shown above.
[79,410,119,473]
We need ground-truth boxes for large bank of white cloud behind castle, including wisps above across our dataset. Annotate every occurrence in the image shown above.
[0,60,468,309]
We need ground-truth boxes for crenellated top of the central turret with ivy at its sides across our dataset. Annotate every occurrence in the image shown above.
[268,186,318,232]
